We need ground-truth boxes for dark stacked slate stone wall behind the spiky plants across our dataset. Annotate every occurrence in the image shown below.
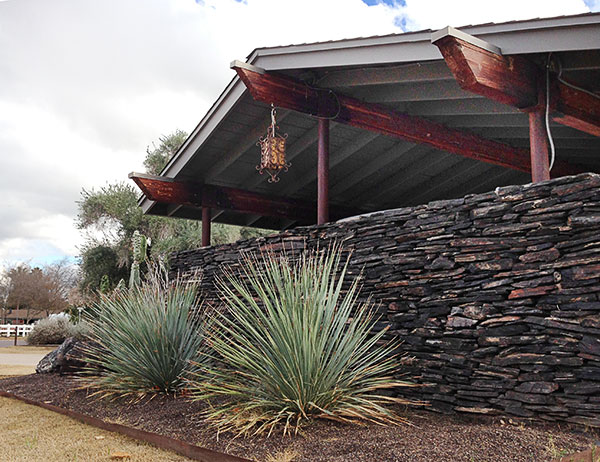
[171,174,600,426]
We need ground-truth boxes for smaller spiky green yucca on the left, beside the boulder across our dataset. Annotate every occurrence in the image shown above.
[84,272,203,395]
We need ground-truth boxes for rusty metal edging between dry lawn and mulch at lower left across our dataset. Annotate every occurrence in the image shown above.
[0,391,252,462]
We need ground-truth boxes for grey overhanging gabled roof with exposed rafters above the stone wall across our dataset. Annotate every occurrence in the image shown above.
[140,14,600,228]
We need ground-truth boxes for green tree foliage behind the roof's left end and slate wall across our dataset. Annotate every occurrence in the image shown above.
[76,130,262,291]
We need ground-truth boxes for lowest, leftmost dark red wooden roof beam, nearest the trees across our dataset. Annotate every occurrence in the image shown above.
[129,173,361,224]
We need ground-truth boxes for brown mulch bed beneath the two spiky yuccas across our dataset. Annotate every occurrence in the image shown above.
[0,374,600,462]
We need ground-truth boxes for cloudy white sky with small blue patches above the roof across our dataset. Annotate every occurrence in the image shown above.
[0,0,600,265]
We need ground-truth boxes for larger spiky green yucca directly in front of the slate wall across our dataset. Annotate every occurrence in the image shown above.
[193,247,409,434]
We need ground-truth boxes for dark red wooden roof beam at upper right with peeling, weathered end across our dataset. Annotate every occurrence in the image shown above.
[432,30,600,136]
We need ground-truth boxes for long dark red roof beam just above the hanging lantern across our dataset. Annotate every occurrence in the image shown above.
[231,61,585,176]
